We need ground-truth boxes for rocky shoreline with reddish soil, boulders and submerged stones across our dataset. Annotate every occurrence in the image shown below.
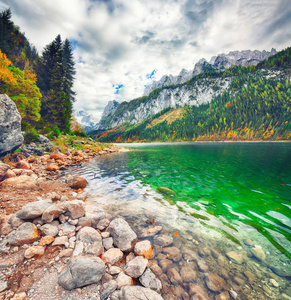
[0,142,291,300]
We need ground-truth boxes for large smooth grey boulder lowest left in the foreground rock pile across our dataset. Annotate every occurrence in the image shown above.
[58,256,105,290]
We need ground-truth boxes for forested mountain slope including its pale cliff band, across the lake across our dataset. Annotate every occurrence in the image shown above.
[100,48,291,141]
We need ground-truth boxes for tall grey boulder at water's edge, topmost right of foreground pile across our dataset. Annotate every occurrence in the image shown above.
[106,218,137,251]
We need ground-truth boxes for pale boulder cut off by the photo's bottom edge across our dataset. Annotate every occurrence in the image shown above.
[120,286,163,300]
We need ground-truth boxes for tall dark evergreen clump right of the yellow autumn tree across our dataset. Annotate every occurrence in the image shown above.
[37,35,75,132]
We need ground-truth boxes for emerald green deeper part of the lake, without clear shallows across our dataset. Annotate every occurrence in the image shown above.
[126,142,291,259]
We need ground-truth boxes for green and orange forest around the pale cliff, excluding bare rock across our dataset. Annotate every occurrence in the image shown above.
[99,48,291,142]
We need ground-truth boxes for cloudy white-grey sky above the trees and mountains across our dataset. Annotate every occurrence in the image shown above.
[0,0,291,117]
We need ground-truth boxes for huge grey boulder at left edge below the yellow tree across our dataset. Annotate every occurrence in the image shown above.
[0,94,24,157]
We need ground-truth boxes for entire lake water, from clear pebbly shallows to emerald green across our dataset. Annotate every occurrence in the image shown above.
[65,143,291,299]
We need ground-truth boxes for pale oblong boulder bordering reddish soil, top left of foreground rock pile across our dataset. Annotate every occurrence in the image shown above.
[16,200,52,220]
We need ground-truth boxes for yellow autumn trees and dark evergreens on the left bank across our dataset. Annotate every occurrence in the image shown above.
[0,9,75,139]
